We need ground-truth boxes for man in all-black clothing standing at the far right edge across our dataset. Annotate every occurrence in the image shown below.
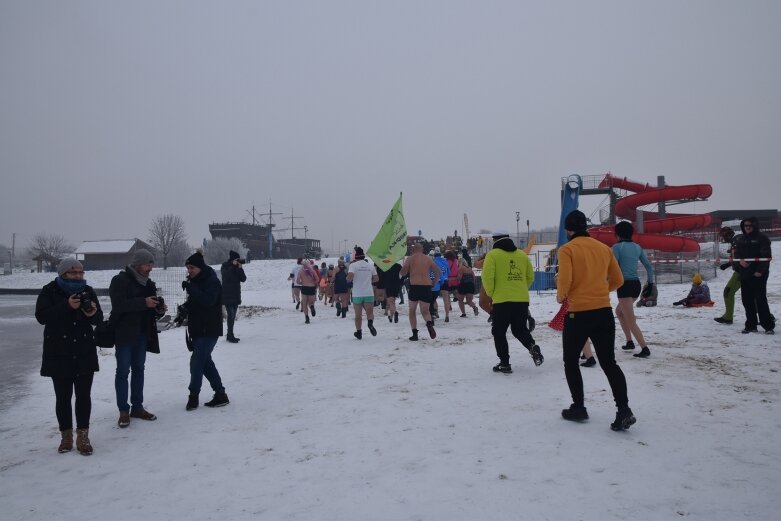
[733,217,776,335]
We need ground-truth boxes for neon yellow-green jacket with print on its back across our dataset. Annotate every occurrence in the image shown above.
[482,248,534,304]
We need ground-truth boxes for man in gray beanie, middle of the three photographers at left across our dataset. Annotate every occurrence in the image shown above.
[109,248,168,428]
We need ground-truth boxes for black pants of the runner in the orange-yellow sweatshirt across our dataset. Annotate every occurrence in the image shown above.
[562,308,629,409]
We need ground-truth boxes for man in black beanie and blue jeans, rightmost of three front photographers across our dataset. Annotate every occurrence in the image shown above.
[182,252,229,411]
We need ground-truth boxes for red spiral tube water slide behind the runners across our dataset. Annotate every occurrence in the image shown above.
[589,174,713,252]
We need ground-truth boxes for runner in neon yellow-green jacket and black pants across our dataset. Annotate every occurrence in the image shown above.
[482,230,545,374]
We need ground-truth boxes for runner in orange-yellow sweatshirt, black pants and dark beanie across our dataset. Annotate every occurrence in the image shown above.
[556,210,636,431]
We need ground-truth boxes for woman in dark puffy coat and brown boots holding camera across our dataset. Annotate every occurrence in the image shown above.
[35,258,103,456]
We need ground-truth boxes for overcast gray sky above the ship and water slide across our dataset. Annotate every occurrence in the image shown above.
[0,0,781,253]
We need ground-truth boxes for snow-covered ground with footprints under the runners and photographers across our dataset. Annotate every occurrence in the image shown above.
[0,243,781,521]
